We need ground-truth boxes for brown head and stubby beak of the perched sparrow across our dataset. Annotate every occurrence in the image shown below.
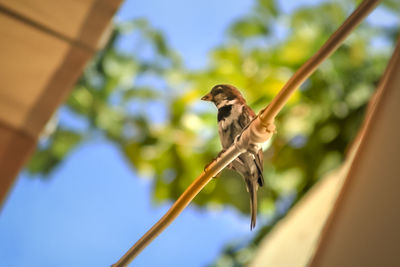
[201,84,246,107]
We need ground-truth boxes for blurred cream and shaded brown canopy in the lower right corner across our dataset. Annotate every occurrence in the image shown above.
[250,39,400,267]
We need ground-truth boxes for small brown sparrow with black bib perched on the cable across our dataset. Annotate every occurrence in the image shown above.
[201,84,264,230]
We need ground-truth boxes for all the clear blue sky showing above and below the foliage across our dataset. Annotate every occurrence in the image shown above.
[0,0,398,267]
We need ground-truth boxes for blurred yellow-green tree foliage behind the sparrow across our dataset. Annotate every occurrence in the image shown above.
[28,0,399,266]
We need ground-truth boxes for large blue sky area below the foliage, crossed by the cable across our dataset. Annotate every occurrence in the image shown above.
[0,140,249,267]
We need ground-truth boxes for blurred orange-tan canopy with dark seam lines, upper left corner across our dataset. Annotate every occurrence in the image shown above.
[0,0,121,204]
